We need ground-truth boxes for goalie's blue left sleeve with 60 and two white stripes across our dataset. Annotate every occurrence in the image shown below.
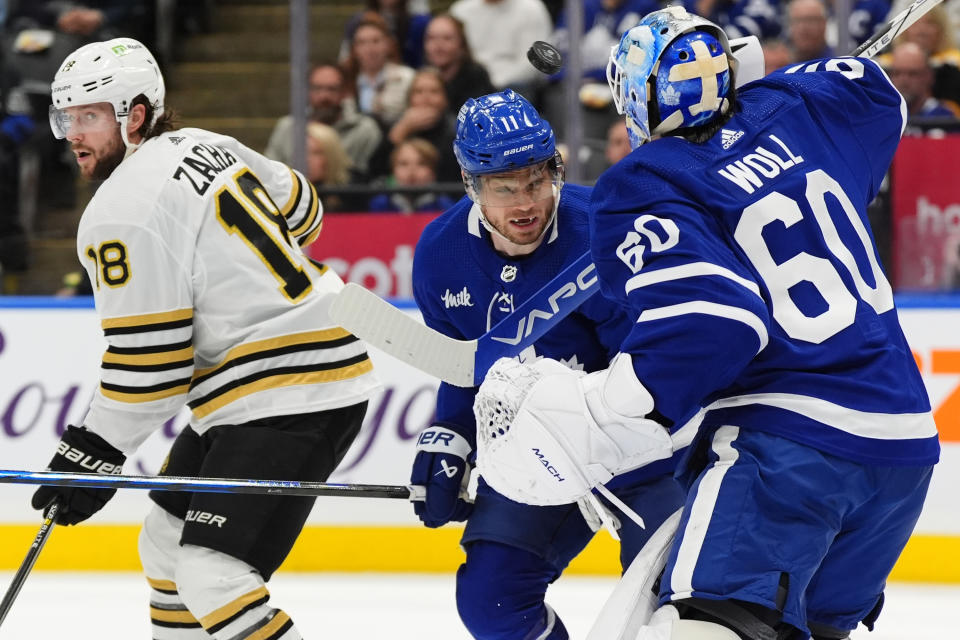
[593,195,771,421]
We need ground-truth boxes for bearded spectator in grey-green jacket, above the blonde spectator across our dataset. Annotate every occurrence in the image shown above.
[264,63,383,180]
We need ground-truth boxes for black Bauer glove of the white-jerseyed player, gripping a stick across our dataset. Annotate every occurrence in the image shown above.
[31,426,127,524]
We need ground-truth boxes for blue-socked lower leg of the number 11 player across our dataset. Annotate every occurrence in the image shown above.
[457,541,569,640]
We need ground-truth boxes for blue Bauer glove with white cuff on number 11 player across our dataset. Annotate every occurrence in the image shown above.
[410,425,473,528]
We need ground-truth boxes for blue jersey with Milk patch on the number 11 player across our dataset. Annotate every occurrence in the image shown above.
[413,184,633,444]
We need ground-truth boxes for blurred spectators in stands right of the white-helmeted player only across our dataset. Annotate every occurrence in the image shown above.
[266,0,960,212]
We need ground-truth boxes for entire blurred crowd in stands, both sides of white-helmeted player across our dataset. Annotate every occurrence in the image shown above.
[0,0,960,288]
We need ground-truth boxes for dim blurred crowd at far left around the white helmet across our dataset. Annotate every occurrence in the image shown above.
[0,0,212,293]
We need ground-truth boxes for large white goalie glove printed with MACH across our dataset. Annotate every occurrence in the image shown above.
[473,353,673,505]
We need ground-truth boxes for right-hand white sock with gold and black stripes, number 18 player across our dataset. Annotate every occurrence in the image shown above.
[176,544,302,640]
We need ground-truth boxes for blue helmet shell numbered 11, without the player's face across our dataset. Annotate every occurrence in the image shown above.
[453,89,563,205]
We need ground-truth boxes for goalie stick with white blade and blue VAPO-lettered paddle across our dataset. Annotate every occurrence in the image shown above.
[330,252,600,387]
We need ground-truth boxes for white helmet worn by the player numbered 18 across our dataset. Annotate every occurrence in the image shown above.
[50,38,166,148]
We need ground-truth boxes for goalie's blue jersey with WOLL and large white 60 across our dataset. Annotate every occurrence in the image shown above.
[591,58,939,465]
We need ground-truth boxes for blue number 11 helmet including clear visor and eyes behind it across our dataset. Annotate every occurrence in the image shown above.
[453,89,563,207]
